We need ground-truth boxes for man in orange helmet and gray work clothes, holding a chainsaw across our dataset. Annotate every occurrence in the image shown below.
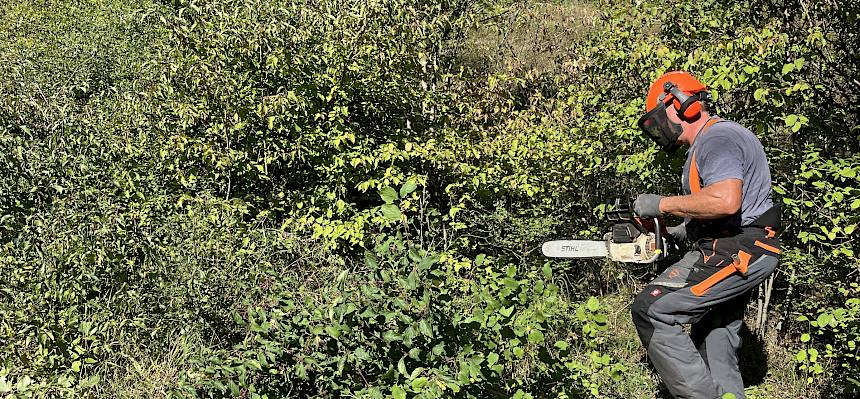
[632,72,780,399]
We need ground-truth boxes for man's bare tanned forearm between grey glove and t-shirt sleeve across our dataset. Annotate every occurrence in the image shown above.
[660,179,743,219]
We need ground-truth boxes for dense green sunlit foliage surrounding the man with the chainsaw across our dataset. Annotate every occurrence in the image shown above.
[0,0,860,398]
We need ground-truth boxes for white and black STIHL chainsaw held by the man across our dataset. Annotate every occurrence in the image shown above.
[541,199,669,263]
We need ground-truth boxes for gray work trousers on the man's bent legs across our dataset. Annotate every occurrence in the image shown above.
[632,251,778,399]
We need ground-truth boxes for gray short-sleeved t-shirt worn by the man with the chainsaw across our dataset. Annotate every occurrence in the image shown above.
[681,120,773,226]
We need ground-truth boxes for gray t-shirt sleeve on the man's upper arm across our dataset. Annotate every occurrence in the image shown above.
[696,131,744,186]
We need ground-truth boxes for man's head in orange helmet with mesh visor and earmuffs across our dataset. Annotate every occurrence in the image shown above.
[639,71,710,153]
